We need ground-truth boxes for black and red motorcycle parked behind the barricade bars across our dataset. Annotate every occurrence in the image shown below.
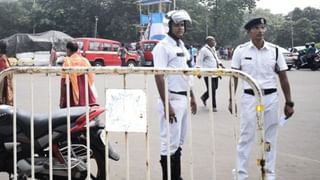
[0,105,119,180]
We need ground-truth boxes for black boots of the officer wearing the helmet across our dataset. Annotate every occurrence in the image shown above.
[160,147,182,180]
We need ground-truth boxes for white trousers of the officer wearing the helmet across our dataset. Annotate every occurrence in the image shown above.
[158,93,188,156]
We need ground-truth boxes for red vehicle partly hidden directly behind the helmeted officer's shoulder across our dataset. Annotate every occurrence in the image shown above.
[140,40,159,66]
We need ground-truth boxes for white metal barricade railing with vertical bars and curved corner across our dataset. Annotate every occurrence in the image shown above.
[0,67,268,180]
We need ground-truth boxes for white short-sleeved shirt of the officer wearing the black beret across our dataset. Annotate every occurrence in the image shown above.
[231,41,288,89]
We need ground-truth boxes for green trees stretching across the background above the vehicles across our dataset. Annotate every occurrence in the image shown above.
[0,0,320,47]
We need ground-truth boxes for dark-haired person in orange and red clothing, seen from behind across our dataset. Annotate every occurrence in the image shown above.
[60,42,96,108]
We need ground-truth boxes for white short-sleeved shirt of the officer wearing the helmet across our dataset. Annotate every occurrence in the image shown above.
[152,35,190,92]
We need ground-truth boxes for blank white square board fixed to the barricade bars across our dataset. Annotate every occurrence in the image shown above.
[105,89,147,133]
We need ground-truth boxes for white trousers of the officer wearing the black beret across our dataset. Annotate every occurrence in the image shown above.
[237,93,279,180]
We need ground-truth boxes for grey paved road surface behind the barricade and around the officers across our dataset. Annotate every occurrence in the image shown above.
[0,62,320,180]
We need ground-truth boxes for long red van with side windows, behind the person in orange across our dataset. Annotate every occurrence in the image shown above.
[75,37,140,66]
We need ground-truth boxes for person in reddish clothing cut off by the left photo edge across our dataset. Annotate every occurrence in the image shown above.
[0,42,13,106]
